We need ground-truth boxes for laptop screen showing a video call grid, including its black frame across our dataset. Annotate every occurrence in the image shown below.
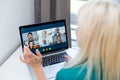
[19,20,68,54]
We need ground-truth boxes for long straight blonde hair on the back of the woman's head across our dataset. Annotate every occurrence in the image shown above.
[66,0,120,80]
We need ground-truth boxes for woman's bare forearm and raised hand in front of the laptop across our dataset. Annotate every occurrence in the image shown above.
[20,46,47,80]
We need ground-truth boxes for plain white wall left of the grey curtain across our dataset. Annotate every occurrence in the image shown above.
[0,0,34,65]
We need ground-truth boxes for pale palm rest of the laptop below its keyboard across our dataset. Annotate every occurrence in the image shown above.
[43,62,65,79]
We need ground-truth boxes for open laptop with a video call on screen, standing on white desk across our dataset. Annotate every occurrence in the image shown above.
[19,20,68,79]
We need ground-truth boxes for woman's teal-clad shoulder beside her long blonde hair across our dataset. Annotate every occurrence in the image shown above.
[56,66,87,80]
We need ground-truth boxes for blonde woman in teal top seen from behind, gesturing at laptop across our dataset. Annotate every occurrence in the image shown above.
[21,0,120,80]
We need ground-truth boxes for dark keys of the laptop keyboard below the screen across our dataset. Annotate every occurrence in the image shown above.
[42,52,67,67]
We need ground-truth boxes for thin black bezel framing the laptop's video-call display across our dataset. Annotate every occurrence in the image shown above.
[19,19,68,54]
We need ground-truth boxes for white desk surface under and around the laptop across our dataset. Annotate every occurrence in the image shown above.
[0,47,78,80]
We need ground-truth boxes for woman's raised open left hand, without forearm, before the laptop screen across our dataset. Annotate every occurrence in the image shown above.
[20,46,42,69]
